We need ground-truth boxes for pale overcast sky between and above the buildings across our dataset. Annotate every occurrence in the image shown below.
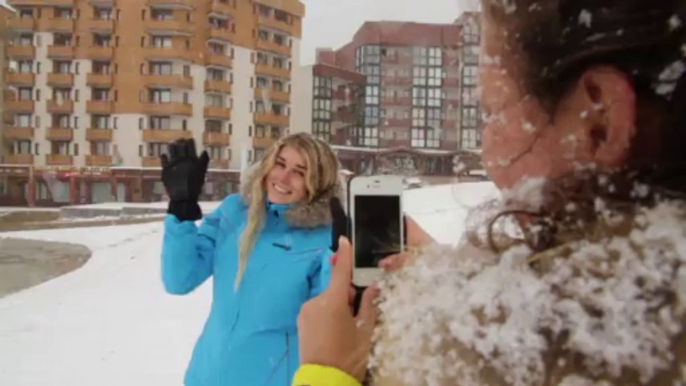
[301,0,475,65]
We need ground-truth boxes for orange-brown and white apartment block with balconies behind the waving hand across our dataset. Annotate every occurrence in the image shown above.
[0,0,304,205]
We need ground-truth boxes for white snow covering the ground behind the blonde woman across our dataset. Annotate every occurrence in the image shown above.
[0,183,497,386]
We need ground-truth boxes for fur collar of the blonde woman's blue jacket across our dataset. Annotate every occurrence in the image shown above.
[240,163,346,228]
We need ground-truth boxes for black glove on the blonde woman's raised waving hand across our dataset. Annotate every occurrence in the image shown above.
[160,139,210,221]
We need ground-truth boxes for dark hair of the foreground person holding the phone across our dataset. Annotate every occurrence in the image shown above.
[482,0,686,251]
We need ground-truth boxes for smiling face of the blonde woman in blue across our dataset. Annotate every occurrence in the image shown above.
[265,146,308,204]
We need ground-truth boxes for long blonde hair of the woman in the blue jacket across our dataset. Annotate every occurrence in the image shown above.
[234,133,339,290]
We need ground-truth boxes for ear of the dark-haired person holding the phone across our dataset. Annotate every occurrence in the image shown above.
[573,66,636,169]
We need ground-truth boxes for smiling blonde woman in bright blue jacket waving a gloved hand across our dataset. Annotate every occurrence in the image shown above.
[162,134,342,386]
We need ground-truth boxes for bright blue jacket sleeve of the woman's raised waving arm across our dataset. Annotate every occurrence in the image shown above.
[162,207,221,295]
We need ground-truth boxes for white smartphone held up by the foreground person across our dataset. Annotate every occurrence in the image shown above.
[349,175,405,287]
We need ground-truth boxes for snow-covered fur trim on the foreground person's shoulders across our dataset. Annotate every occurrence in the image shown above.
[371,198,686,386]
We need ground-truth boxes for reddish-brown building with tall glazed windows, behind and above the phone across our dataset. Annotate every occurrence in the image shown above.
[294,22,480,181]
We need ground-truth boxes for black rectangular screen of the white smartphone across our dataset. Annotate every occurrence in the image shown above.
[353,195,402,268]
